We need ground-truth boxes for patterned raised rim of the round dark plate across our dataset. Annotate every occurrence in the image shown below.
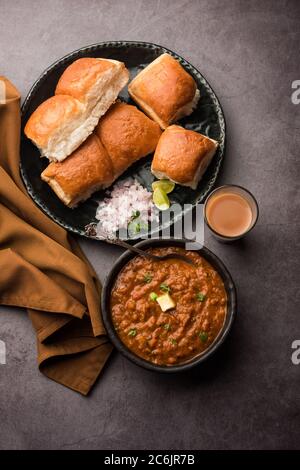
[19,40,226,242]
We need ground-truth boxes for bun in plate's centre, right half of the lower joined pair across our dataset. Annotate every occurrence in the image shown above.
[96,102,161,175]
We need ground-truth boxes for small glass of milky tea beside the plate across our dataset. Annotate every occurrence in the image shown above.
[204,184,258,242]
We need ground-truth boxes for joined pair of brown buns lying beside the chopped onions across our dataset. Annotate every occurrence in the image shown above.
[41,102,161,207]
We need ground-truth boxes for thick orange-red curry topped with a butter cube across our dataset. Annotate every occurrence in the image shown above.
[111,247,227,366]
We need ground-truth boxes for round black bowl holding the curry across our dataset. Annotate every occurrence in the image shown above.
[101,238,237,373]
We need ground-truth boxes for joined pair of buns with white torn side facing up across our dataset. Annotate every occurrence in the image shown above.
[24,57,129,161]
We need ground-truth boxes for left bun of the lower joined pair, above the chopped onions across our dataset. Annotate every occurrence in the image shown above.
[42,134,114,199]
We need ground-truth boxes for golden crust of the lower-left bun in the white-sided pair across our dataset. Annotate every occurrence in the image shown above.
[24,95,81,146]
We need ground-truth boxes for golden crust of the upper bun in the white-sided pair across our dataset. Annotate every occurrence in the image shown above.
[55,57,115,100]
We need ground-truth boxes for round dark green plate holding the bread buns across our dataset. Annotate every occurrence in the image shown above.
[21,41,225,238]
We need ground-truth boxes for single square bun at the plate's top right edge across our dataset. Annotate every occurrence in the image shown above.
[128,54,200,129]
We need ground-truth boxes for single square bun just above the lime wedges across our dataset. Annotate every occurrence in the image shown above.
[151,125,219,189]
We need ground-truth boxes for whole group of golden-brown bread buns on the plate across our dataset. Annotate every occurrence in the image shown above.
[24,54,217,207]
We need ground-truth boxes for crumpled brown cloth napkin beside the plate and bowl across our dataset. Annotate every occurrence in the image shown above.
[0,77,112,395]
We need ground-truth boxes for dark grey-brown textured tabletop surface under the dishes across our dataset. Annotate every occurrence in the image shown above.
[0,0,300,449]
